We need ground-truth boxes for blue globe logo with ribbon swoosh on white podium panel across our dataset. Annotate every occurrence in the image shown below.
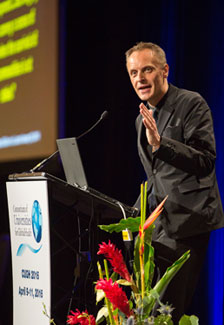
[16,200,43,256]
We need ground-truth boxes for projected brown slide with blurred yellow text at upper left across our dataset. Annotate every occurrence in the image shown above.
[0,0,58,162]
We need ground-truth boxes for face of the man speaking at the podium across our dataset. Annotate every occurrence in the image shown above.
[127,49,169,106]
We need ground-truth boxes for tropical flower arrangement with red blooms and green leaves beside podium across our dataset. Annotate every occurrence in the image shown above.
[46,183,198,325]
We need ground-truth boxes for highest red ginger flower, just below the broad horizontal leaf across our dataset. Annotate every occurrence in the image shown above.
[97,240,132,282]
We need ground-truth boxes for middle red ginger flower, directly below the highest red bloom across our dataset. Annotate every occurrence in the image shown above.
[96,279,132,317]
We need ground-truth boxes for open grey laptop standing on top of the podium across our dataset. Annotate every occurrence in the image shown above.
[56,137,138,216]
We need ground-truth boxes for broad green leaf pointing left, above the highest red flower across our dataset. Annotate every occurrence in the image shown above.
[98,217,140,233]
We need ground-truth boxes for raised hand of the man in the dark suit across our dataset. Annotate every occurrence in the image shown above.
[139,103,160,151]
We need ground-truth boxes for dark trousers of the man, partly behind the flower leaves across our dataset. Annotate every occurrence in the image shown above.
[152,233,210,325]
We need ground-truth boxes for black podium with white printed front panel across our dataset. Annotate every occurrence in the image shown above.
[6,172,138,325]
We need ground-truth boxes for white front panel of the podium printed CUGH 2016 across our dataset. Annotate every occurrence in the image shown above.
[6,180,51,325]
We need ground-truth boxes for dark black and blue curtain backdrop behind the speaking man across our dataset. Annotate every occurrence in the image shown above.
[1,0,224,325]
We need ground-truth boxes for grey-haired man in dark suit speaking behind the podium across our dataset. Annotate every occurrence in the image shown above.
[126,42,224,324]
